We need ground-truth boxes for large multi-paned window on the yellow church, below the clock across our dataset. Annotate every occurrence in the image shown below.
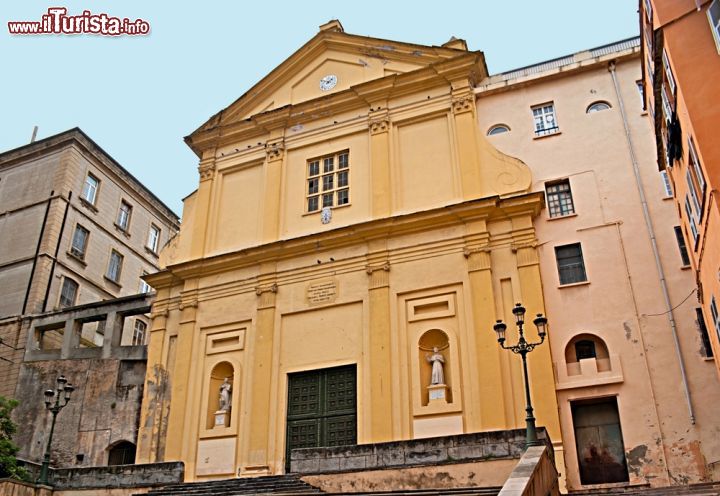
[305,150,350,212]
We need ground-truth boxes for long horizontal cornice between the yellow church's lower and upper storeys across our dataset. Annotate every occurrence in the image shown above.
[146,192,543,289]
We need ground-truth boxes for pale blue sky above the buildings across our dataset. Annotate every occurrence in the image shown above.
[0,0,638,214]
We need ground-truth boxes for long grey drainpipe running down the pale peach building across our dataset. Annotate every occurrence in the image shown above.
[608,61,695,424]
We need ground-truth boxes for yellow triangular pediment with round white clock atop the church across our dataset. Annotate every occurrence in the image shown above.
[188,21,476,140]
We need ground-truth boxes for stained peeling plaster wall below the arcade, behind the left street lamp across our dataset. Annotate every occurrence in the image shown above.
[13,359,145,467]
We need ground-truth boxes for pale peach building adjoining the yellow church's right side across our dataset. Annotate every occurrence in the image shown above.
[475,38,720,489]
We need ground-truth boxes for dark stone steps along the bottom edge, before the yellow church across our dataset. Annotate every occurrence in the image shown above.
[139,475,500,496]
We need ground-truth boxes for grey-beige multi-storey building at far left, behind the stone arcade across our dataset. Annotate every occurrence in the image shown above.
[0,128,179,396]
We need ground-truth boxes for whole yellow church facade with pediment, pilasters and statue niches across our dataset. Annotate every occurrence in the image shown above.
[137,21,563,480]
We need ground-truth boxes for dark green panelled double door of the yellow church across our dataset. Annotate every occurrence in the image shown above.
[285,365,357,470]
